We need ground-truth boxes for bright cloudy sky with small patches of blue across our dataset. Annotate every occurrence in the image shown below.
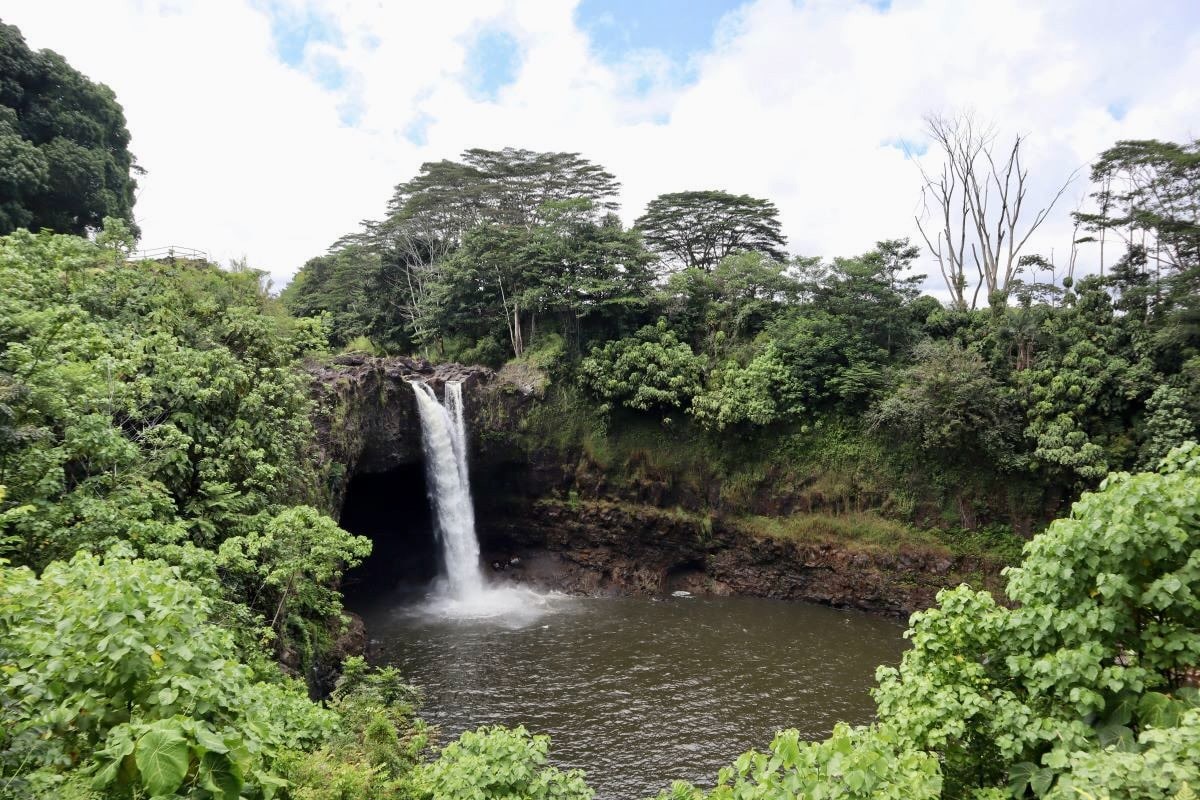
[2,0,1200,287]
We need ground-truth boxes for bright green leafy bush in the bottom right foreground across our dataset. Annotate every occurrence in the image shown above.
[876,444,1200,800]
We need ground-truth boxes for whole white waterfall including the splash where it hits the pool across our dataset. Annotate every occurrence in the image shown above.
[409,380,546,624]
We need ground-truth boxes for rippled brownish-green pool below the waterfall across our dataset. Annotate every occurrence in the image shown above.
[358,596,904,800]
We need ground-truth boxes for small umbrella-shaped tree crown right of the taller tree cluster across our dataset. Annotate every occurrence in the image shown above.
[634,191,787,272]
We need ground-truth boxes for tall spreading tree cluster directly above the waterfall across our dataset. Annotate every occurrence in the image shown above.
[283,148,628,352]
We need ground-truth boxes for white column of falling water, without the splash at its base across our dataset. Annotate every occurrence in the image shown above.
[410,380,484,601]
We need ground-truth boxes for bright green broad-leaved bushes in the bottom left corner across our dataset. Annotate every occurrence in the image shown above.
[0,548,428,800]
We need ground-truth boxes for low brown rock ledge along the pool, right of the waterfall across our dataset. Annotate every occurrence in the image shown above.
[472,500,1000,616]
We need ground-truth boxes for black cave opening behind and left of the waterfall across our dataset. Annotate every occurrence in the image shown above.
[341,464,440,606]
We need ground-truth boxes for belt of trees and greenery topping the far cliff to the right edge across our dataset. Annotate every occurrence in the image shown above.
[292,142,1200,535]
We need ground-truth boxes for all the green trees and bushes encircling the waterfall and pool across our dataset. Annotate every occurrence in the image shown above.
[0,18,1200,800]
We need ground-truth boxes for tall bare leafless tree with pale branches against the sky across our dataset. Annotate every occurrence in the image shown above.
[913,114,1074,308]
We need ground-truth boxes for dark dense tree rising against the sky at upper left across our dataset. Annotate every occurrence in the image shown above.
[0,23,140,235]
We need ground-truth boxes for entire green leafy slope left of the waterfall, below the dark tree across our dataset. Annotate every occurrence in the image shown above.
[0,226,609,800]
